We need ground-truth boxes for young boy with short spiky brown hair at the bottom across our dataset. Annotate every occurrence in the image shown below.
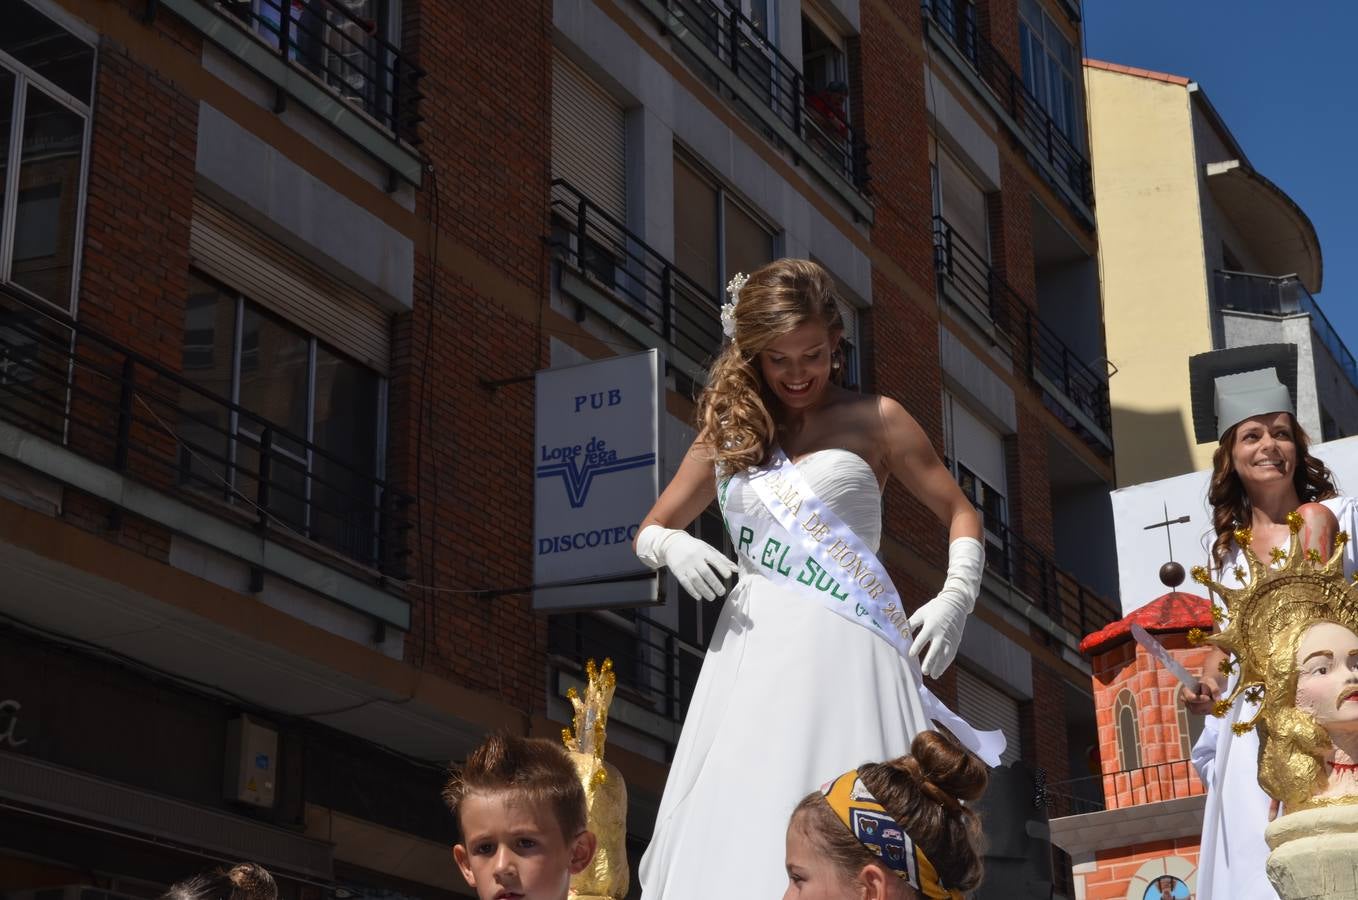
[443,734,595,900]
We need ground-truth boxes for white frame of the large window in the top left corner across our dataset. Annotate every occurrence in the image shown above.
[0,10,99,319]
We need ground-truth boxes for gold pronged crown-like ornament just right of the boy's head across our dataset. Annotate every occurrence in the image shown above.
[561,658,630,900]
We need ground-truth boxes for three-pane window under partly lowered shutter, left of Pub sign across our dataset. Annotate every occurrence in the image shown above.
[179,273,384,561]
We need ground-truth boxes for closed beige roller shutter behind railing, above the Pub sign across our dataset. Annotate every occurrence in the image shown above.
[551,52,627,225]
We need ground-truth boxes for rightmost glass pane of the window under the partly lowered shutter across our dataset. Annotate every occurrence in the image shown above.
[311,345,380,559]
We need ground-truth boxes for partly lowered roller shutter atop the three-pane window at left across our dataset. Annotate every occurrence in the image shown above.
[189,197,391,376]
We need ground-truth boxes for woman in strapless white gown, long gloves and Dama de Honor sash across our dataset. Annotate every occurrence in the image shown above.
[637,259,983,900]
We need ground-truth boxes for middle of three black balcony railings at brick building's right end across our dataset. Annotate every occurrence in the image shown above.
[934,216,1112,456]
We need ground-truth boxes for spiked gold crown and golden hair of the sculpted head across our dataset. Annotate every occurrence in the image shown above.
[1190,512,1358,809]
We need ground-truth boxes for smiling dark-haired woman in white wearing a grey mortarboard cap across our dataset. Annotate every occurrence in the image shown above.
[1180,350,1358,900]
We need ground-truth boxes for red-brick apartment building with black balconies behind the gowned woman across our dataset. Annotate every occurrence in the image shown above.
[0,0,1118,897]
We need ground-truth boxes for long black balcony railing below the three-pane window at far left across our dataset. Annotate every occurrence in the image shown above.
[0,292,410,578]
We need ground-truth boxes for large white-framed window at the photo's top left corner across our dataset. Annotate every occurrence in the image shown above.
[0,0,94,312]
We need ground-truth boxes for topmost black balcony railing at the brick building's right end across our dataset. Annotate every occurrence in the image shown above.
[922,0,1095,208]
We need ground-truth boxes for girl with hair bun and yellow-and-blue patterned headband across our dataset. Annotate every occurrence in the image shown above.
[784,732,987,900]
